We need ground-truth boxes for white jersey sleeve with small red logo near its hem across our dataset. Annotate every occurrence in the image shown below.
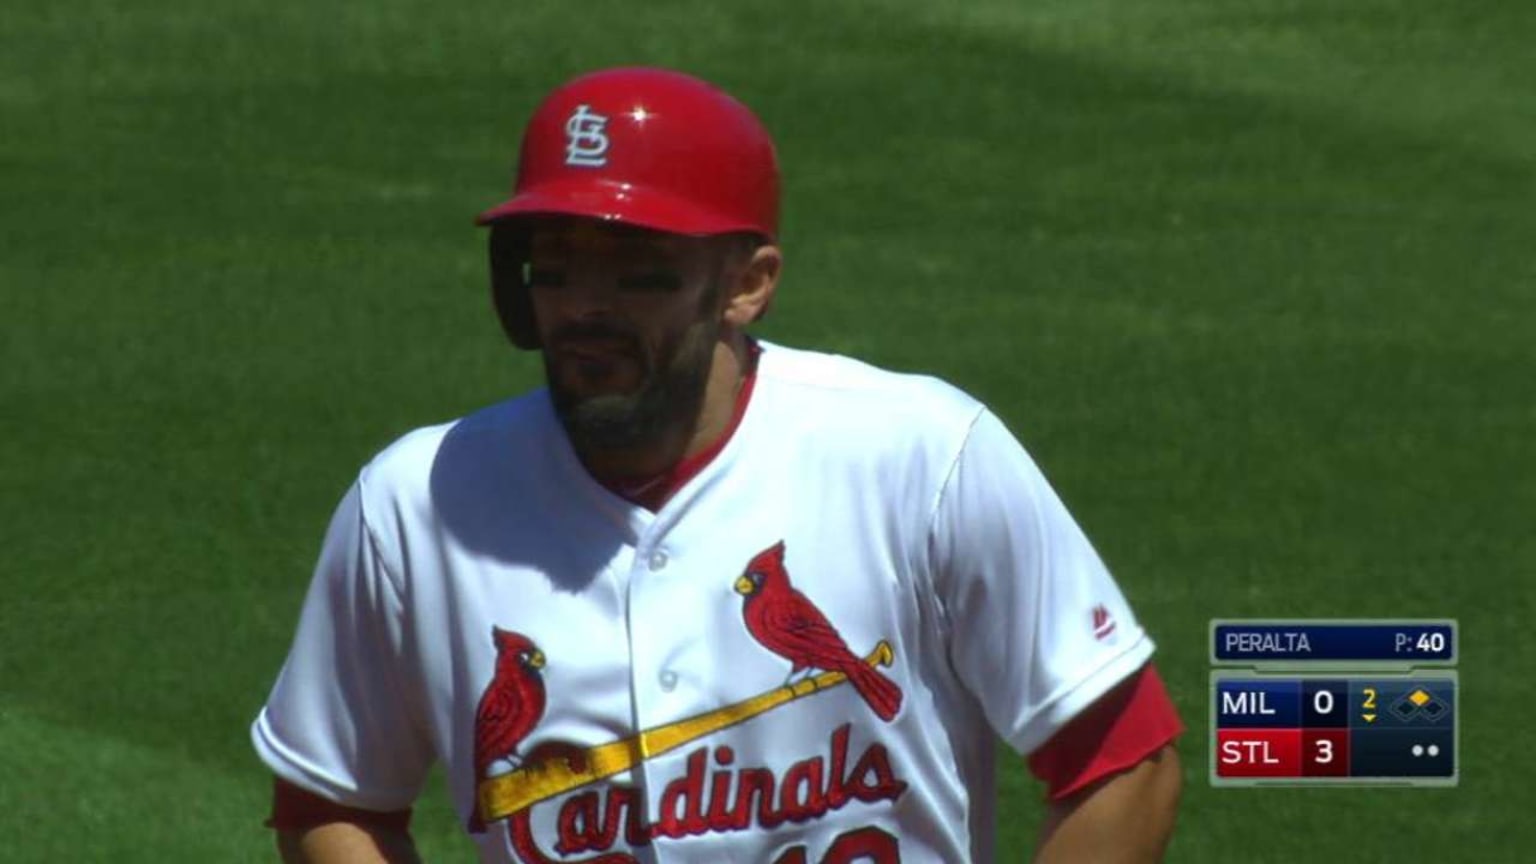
[928,410,1152,753]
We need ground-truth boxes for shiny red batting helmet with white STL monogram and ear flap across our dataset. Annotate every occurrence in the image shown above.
[476,68,779,347]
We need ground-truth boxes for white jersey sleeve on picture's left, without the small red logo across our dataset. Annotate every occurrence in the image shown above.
[250,481,433,810]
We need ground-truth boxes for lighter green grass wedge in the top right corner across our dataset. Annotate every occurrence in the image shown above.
[863,0,1536,166]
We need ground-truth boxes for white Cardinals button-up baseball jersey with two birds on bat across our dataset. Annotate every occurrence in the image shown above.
[252,344,1152,864]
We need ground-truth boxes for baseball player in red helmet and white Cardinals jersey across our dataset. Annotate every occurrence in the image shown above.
[252,68,1181,864]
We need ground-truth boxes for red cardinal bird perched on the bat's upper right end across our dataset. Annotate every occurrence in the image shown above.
[736,540,902,723]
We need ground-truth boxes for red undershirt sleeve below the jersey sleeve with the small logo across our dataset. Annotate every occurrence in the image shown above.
[1029,663,1184,801]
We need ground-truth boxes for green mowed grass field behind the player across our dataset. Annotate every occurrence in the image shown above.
[0,0,1536,864]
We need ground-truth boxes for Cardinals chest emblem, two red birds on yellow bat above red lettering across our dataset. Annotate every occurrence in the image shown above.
[468,543,906,864]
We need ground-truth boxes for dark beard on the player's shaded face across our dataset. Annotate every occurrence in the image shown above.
[544,320,720,454]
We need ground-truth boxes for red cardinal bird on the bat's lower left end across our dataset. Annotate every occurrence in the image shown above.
[470,627,545,833]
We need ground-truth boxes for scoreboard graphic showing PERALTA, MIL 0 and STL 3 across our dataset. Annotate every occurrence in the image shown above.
[1210,620,1459,787]
